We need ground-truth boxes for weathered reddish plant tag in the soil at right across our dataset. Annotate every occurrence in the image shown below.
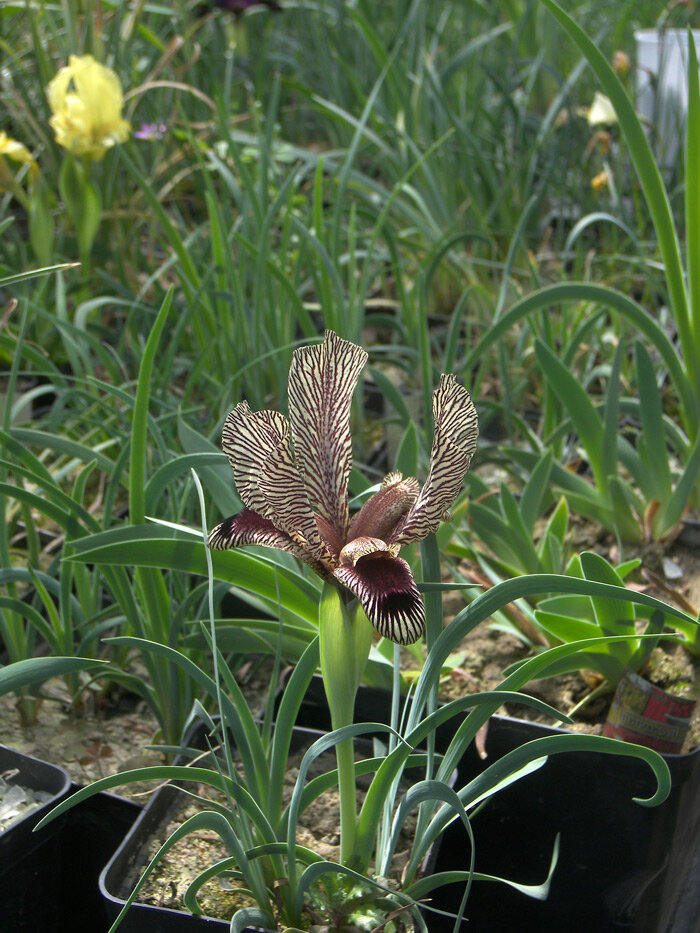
[603,671,696,754]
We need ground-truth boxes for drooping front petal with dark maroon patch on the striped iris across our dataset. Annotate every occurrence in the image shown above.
[334,551,425,645]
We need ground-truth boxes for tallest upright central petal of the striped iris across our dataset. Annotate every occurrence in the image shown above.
[288,331,367,538]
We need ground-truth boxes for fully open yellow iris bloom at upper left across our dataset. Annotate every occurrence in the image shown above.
[46,55,131,160]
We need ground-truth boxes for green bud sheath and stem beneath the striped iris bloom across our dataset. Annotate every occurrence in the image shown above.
[318,583,372,868]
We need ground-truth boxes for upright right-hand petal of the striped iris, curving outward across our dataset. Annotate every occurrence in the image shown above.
[387,375,479,544]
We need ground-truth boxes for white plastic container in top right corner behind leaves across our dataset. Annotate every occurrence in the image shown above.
[634,29,700,169]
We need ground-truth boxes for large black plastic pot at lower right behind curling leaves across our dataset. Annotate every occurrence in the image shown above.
[300,680,700,933]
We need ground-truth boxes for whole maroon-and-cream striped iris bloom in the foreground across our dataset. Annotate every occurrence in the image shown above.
[208,331,478,645]
